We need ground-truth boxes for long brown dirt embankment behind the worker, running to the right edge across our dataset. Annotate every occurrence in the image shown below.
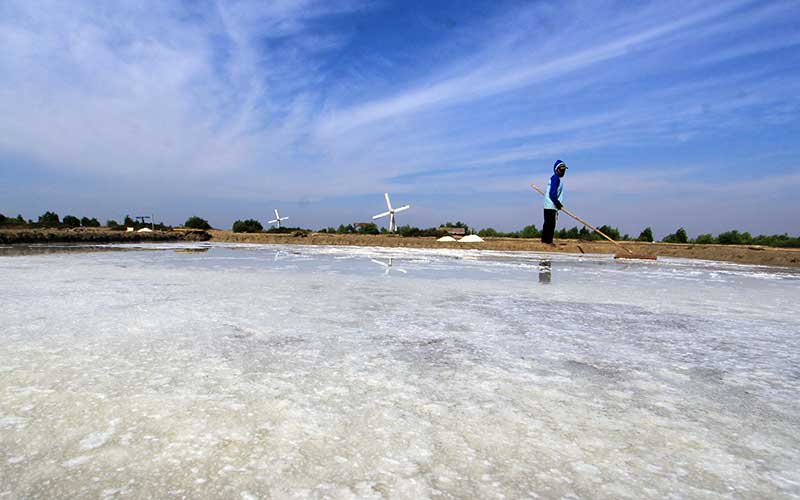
[209,230,800,267]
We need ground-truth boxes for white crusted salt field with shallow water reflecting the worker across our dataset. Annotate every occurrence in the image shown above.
[0,244,800,499]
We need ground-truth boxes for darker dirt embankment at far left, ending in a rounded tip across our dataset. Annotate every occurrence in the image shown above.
[0,228,211,245]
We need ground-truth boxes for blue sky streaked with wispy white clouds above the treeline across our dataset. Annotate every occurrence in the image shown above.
[0,0,800,235]
